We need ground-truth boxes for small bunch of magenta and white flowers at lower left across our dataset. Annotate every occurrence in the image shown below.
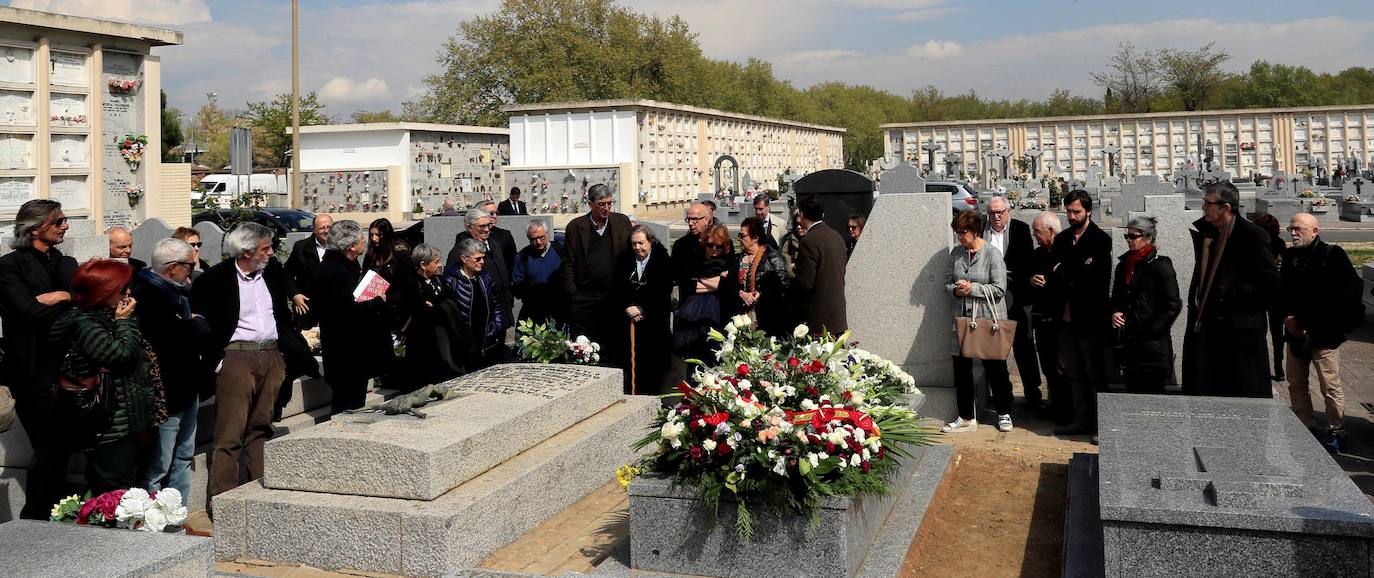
[49,487,185,531]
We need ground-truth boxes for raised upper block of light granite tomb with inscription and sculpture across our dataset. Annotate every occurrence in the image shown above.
[262,364,621,500]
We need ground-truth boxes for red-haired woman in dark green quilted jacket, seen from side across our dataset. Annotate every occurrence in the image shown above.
[51,259,166,496]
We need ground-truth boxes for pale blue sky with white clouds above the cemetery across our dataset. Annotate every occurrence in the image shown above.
[10,0,1374,118]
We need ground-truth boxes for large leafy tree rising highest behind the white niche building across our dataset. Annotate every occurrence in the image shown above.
[405,0,708,125]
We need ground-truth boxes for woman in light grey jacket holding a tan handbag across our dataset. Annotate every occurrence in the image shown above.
[941,211,1015,432]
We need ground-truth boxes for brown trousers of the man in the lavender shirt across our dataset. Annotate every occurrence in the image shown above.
[210,349,286,497]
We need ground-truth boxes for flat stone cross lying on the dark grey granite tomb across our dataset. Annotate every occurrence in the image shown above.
[1154,444,1303,508]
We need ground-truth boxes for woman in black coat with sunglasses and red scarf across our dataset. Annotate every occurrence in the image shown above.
[1112,217,1183,394]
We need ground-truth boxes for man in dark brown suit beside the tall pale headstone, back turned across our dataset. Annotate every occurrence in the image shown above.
[794,195,849,336]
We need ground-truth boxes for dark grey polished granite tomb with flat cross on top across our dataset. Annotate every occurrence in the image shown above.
[1098,394,1374,577]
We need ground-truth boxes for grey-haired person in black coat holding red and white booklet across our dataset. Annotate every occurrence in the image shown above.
[312,220,394,413]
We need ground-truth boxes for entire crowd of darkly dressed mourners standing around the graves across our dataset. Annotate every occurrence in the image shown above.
[0,174,1363,519]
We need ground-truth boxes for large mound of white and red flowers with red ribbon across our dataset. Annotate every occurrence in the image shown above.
[635,316,937,541]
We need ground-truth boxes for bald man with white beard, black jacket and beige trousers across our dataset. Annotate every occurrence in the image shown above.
[1279,213,1364,453]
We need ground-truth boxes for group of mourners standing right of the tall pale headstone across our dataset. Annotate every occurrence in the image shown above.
[943,181,1364,450]
